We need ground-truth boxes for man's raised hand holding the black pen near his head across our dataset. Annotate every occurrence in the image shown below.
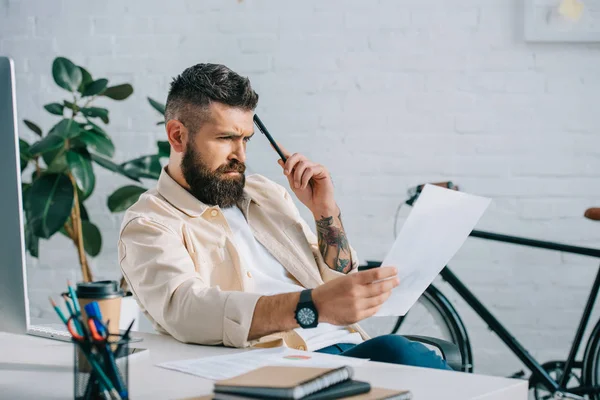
[277,146,339,216]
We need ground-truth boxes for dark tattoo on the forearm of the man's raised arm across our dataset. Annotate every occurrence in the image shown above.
[316,214,352,273]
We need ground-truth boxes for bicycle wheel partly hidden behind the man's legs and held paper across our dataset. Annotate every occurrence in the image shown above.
[360,285,473,372]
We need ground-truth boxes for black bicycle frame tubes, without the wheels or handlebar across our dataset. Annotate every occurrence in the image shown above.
[440,230,600,393]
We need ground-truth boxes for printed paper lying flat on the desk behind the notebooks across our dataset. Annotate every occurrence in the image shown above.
[157,347,368,380]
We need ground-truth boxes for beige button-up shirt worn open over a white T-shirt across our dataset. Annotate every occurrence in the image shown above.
[119,170,368,349]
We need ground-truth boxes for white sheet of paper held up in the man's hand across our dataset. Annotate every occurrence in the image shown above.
[375,185,491,316]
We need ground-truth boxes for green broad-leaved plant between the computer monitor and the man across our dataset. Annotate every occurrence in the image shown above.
[19,57,139,282]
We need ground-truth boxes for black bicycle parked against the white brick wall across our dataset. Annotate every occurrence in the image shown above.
[360,182,600,400]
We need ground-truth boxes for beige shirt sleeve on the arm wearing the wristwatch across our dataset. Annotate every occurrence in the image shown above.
[119,217,261,347]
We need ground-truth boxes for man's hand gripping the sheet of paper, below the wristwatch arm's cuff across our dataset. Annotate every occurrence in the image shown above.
[312,267,400,325]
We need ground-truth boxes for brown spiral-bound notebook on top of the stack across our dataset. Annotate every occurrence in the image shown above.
[214,366,354,400]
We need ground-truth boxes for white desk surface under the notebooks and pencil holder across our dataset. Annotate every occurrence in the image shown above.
[0,332,527,400]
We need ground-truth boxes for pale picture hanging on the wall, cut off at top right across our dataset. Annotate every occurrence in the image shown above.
[523,0,600,42]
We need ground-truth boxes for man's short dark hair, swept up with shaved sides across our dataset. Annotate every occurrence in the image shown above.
[165,64,258,134]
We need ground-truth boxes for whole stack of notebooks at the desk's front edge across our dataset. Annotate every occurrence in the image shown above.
[207,366,412,400]
